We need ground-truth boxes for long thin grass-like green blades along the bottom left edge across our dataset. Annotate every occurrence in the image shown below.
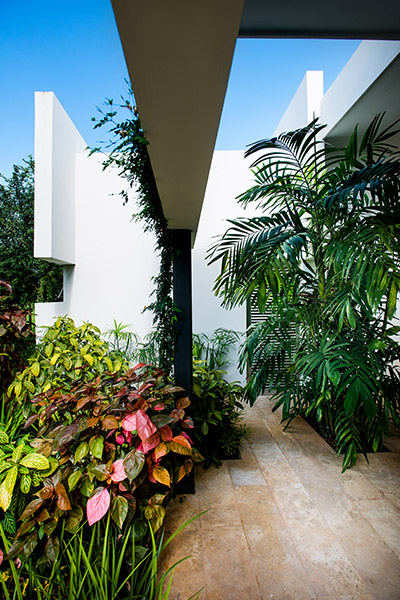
[0,515,205,600]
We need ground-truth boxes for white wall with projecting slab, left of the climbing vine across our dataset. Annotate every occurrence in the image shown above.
[35,92,158,338]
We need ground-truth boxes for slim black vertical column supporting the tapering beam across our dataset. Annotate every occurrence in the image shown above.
[172,229,193,399]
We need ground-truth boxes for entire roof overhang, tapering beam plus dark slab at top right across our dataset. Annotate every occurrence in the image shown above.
[112,0,400,239]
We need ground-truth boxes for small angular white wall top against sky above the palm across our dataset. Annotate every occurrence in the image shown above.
[271,71,324,137]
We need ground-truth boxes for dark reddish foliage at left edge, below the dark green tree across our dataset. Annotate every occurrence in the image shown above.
[0,281,35,396]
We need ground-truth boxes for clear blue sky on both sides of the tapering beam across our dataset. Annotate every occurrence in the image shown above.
[0,0,359,176]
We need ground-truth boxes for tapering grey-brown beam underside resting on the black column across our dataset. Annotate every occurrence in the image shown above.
[113,0,243,231]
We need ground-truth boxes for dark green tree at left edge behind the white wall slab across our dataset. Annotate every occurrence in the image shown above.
[0,156,62,308]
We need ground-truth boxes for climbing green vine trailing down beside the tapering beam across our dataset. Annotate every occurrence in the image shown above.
[90,88,177,375]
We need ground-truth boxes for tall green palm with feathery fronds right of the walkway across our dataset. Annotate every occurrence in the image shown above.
[209,115,400,469]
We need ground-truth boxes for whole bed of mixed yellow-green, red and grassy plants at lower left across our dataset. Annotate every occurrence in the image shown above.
[0,317,202,600]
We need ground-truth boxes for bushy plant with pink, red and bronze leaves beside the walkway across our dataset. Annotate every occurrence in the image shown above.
[8,364,202,559]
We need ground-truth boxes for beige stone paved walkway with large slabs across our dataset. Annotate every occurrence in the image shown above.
[164,397,400,600]
